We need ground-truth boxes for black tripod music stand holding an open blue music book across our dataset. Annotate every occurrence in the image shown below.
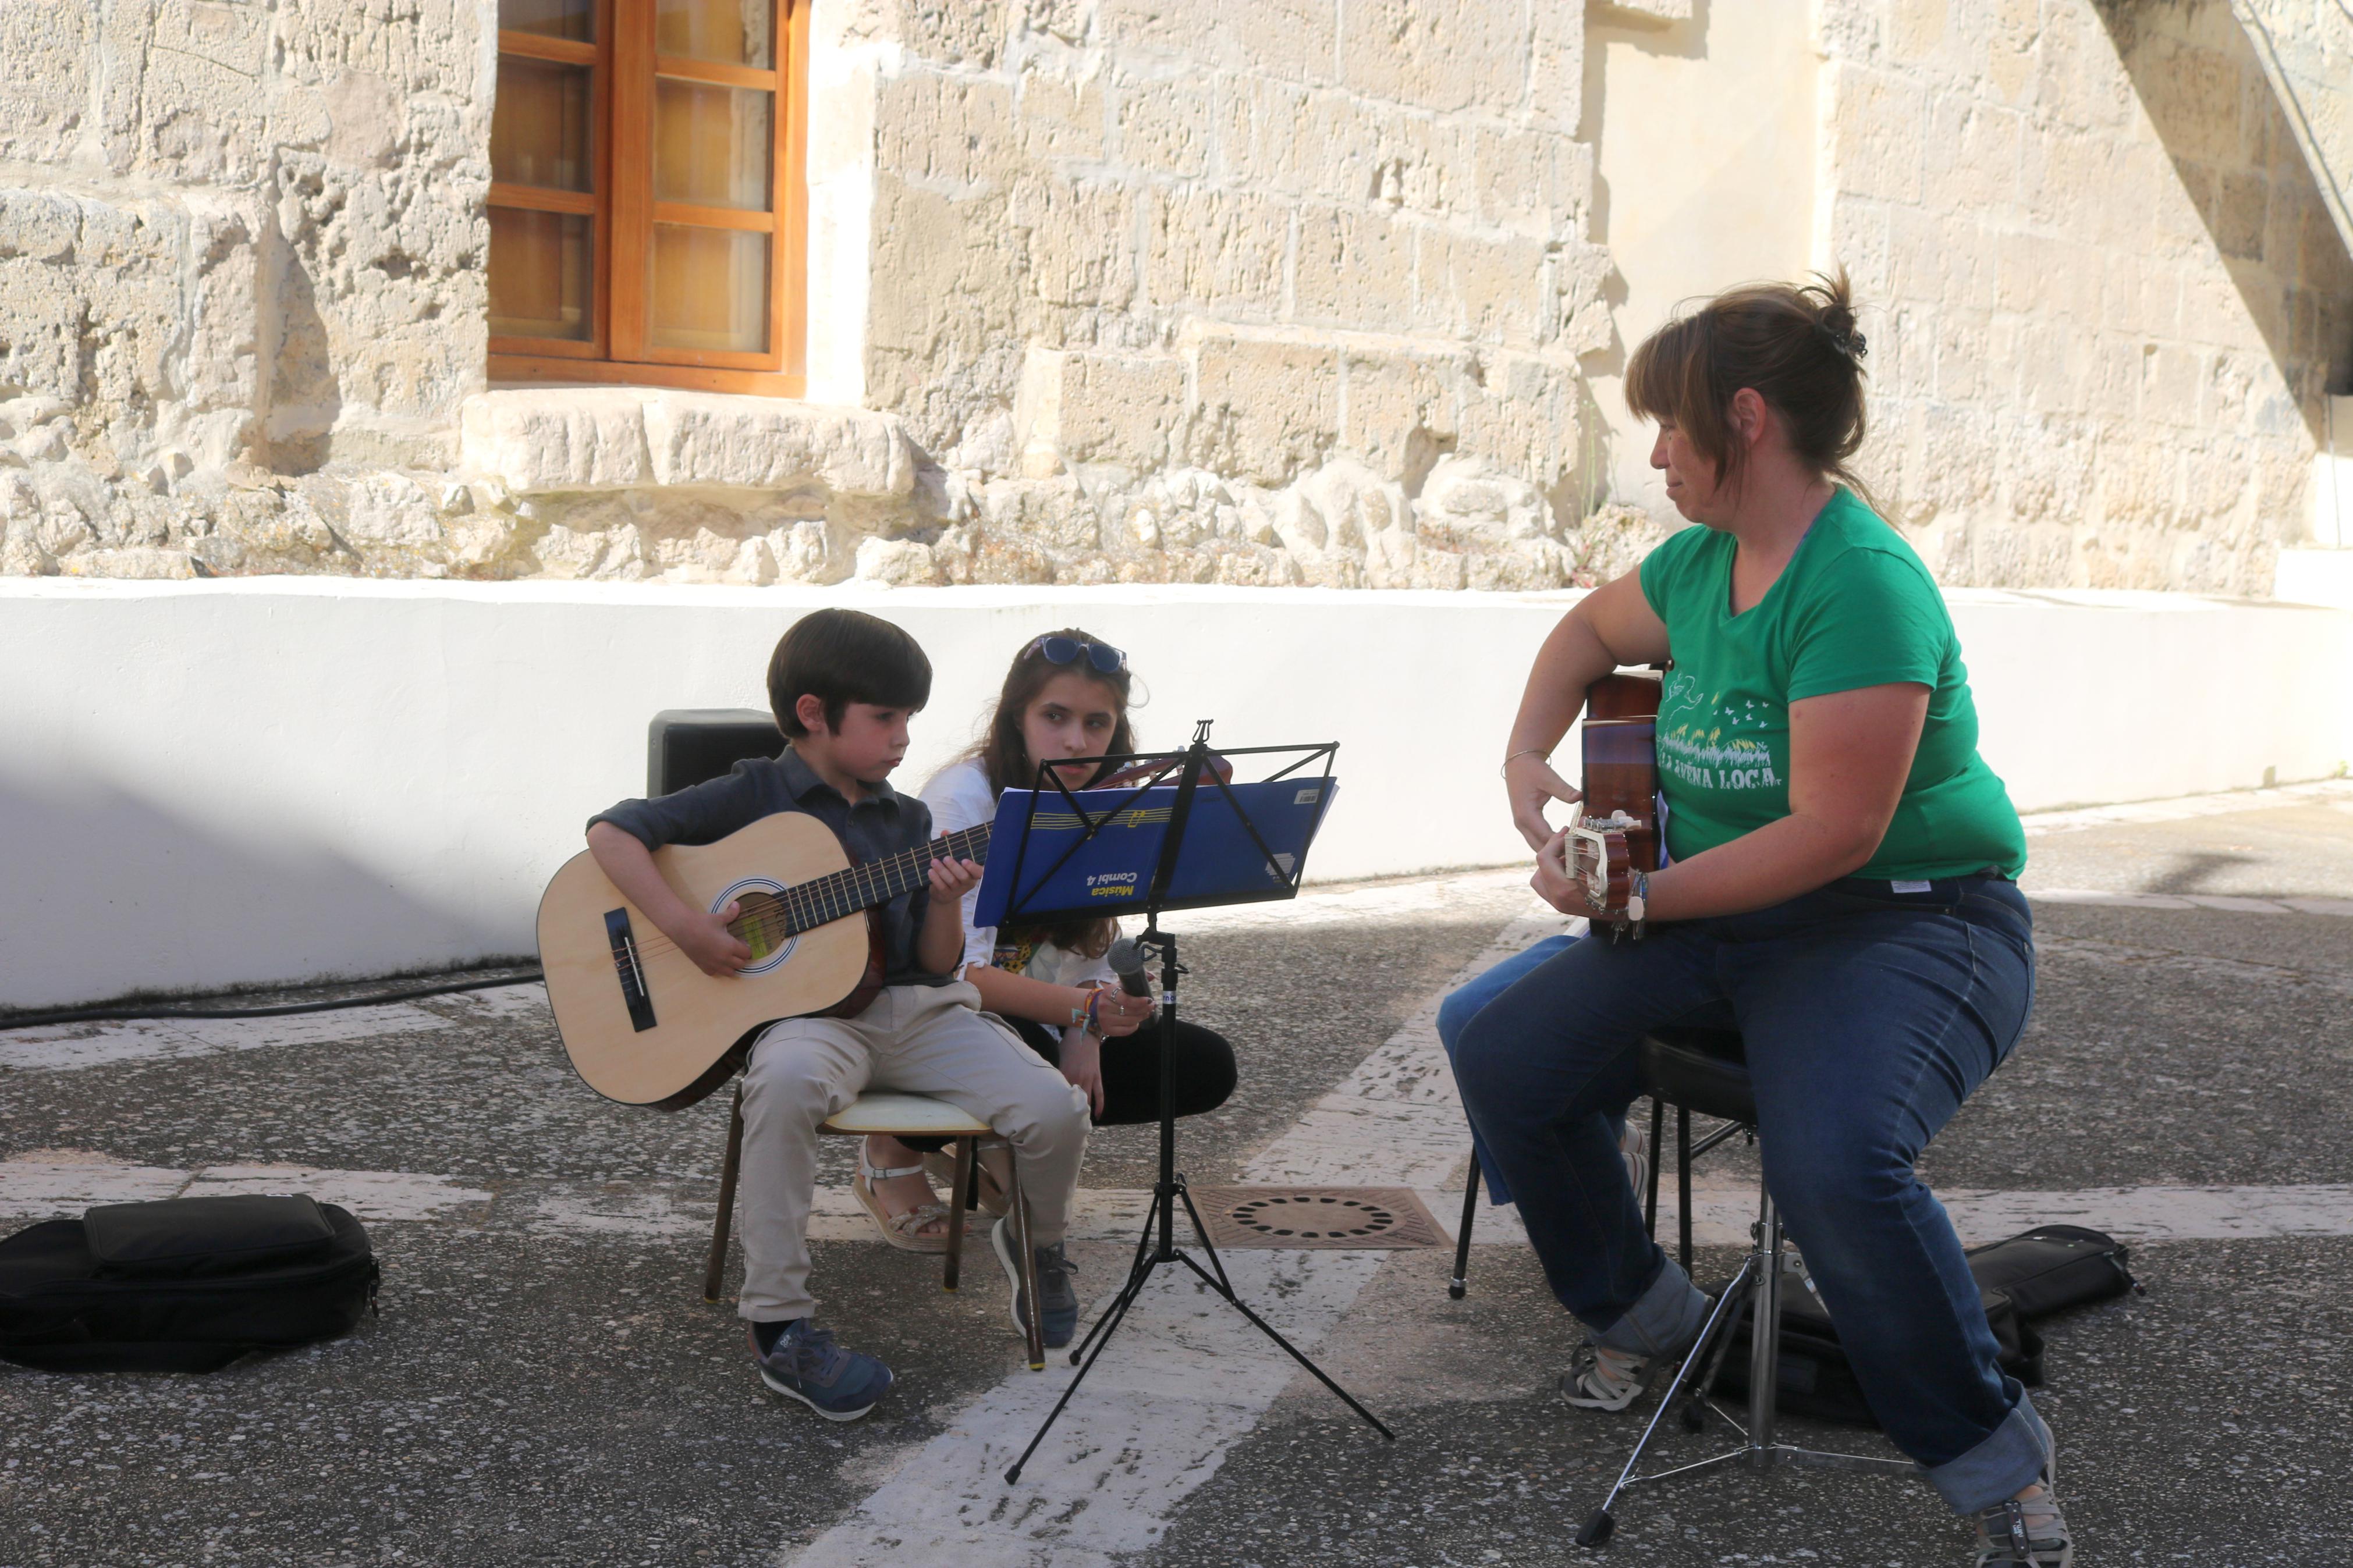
[993,719,1398,1484]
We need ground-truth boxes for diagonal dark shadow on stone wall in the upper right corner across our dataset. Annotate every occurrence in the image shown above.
[2094,0,2353,442]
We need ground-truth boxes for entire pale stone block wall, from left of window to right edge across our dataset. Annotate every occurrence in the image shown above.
[0,0,2353,592]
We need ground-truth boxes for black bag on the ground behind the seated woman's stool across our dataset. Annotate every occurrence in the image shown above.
[1713,1225,2136,1427]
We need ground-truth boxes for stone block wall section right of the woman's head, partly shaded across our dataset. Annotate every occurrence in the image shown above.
[1816,0,2353,595]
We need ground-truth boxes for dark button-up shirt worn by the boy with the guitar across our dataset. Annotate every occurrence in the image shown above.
[588,748,955,985]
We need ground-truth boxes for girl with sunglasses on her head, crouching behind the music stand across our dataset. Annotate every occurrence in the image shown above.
[857,630,1236,1251]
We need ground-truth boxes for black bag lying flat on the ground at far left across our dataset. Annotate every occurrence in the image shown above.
[0,1197,379,1373]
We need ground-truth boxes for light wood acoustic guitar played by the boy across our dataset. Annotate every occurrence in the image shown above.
[539,811,988,1110]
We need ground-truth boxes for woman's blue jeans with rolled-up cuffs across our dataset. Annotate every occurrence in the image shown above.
[1454,877,2049,1514]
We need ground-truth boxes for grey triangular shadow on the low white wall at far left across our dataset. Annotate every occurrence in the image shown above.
[0,776,491,1008]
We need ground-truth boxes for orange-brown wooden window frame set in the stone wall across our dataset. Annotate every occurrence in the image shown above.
[489,0,812,397]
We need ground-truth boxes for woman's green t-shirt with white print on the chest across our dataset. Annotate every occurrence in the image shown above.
[1642,486,2026,881]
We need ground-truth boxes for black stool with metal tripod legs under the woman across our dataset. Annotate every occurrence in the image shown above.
[1571,1030,1920,1547]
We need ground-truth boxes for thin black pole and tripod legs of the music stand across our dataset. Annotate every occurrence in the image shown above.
[1005,719,1398,1486]
